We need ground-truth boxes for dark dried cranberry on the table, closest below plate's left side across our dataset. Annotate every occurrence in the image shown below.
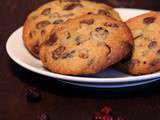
[25,88,42,102]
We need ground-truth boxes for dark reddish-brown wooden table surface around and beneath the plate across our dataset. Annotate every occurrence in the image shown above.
[0,0,160,120]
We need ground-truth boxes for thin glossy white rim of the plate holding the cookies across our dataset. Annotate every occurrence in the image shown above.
[6,8,160,83]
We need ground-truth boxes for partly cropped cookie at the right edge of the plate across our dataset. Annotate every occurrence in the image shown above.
[121,12,160,75]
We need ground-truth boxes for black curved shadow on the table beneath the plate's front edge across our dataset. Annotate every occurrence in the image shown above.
[10,61,160,99]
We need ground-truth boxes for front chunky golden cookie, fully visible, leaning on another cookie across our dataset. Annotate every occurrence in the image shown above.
[40,14,133,75]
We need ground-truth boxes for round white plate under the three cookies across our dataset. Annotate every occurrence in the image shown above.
[6,8,160,86]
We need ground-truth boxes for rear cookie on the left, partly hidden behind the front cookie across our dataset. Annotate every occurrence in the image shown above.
[23,0,120,57]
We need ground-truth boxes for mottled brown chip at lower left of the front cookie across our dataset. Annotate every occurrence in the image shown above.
[52,46,65,60]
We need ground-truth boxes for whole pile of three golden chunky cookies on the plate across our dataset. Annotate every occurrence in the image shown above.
[23,0,160,75]
